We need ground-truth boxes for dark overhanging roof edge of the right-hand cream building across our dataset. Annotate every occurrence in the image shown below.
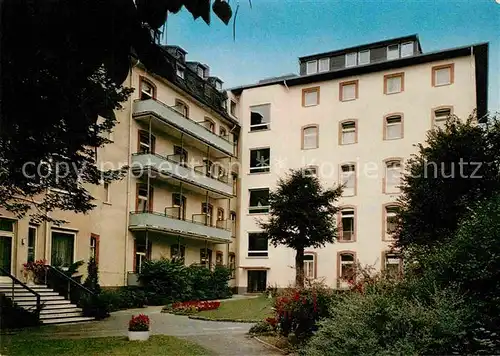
[228,41,489,117]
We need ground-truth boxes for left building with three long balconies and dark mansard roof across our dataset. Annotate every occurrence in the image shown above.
[0,46,240,286]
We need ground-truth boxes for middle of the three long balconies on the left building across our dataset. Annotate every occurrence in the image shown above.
[132,153,233,199]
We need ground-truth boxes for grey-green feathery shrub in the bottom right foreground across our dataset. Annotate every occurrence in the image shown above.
[301,288,465,356]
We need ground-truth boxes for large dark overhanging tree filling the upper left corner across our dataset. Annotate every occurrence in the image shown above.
[0,0,232,220]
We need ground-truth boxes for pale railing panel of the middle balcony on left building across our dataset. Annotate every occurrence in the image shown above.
[132,153,233,197]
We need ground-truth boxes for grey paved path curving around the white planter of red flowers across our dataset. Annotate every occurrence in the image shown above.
[8,307,281,356]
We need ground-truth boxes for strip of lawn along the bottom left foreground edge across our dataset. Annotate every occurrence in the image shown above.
[0,334,214,356]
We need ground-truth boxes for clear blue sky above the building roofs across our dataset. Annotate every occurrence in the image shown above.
[166,0,500,111]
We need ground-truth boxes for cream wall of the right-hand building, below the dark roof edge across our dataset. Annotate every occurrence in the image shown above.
[230,38,488,292]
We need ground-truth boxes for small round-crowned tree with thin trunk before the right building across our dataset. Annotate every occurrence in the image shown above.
[259,170,342,287]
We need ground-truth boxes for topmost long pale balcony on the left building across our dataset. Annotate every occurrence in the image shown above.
[133,99,234,156]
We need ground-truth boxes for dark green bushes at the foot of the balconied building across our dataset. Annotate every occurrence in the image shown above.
[139,259,231,305]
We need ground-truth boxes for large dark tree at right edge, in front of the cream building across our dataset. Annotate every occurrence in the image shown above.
[395,114,500,249]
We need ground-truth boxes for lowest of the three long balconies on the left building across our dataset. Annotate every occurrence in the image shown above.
[129,207,231,243]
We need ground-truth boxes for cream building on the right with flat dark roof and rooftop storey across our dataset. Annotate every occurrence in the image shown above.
[230,35,488,293]
